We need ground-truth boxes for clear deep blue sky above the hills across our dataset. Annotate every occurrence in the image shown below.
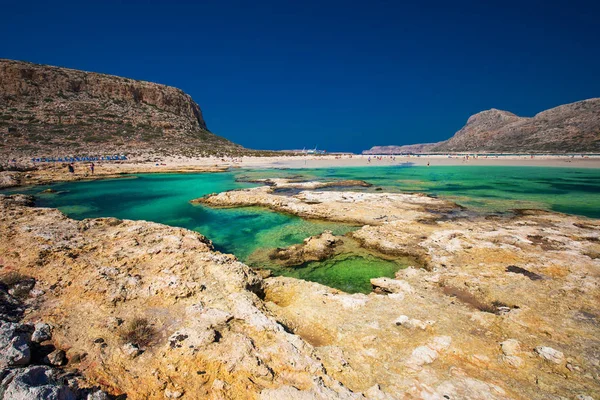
[0,0,600,152]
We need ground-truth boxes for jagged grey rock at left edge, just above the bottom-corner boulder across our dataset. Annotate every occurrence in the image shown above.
[0,321,31,368]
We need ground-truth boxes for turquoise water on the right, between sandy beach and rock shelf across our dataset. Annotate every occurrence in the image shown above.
[240,164,600,218]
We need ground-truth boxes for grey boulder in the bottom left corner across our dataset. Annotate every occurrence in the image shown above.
[0,366,76,400]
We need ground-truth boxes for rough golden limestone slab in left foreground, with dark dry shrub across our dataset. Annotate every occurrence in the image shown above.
[0,196,362,399]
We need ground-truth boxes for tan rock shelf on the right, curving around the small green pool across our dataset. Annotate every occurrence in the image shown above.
[196,182,600,399]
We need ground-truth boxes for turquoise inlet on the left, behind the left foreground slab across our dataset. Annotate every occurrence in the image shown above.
[14,172,355,260]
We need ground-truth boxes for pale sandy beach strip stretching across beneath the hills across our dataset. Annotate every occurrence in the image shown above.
[0,155,600,188]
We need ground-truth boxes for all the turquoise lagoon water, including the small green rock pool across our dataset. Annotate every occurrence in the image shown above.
[5,164,600,292]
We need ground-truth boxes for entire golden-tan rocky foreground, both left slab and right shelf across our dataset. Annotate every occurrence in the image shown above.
[0,181,600,400]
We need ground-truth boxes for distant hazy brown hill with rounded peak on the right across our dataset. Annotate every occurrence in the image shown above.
[365,98,600,154]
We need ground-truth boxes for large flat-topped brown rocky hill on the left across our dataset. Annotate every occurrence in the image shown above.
[0,59,244,157]
